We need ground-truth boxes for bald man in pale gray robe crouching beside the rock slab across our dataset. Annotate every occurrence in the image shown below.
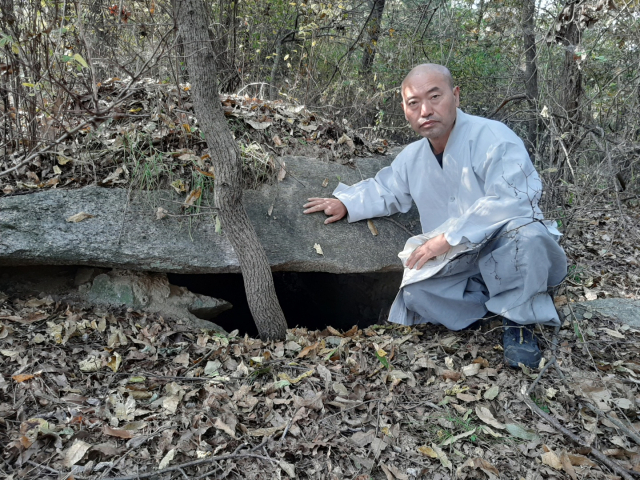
[304,64,567,368]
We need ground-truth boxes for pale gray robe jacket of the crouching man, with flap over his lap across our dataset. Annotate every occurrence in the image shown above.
[333,110,566,330]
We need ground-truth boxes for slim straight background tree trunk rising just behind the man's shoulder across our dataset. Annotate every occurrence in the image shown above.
[522,0,539,160]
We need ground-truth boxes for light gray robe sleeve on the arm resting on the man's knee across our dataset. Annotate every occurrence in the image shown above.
[445,141,542,245]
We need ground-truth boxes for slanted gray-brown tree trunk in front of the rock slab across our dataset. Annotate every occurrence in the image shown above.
[177,0,287,340]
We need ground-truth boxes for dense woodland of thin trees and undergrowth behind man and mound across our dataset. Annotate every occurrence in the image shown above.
[0,0,640,202]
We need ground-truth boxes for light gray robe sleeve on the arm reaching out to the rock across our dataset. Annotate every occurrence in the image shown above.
[333,160,413,223]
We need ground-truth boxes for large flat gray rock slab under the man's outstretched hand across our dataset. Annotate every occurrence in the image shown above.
[0,156,420,273]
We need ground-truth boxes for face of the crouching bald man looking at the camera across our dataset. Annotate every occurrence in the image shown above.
[402,72,460,145]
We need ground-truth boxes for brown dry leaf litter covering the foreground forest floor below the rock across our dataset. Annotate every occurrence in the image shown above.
[0,264,640,480]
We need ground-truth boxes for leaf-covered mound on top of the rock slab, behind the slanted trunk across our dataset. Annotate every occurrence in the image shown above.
[0,78,389,198]
